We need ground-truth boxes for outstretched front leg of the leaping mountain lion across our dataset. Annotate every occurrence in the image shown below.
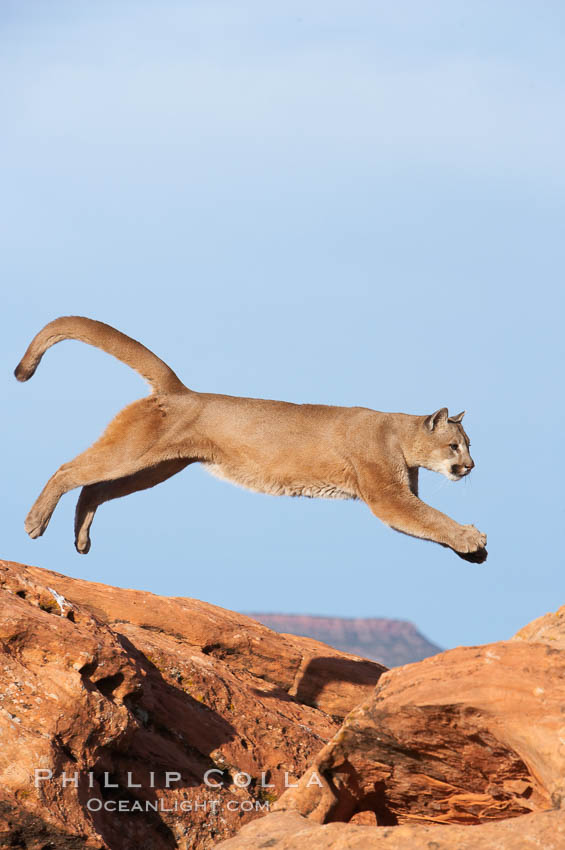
[361,470,487,564]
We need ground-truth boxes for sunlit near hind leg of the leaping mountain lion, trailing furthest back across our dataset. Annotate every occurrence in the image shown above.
[24,396,166,538]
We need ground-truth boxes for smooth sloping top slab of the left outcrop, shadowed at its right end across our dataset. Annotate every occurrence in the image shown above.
[19,562,386,719]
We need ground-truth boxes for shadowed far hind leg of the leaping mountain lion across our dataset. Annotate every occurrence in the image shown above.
[75,458,193,555]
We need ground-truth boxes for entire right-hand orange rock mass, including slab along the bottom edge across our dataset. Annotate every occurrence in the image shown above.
[215,607,565,850]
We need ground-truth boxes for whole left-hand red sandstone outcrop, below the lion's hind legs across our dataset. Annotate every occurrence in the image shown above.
[0,561,383,850]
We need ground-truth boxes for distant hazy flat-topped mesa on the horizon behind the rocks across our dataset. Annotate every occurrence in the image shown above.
[243,613,443,667]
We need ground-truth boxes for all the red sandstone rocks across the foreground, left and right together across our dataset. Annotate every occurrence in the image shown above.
[0,561,565,850]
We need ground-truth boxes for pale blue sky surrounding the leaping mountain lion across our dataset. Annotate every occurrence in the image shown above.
[0,0,565,647]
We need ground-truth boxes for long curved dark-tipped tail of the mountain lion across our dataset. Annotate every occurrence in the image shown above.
[14,316,187,393]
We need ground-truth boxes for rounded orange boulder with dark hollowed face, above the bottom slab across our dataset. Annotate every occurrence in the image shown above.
[275,641,565,825]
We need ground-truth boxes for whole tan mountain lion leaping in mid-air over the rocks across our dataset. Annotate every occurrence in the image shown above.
[16,316,487,562]
